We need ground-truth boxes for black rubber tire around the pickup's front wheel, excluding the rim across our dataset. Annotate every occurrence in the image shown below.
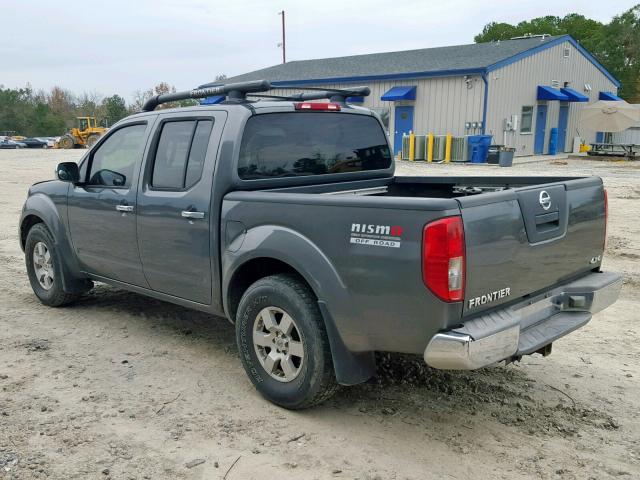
[24,223,80,307]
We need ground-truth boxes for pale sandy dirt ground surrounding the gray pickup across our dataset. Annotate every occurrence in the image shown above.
[0,150,640,480]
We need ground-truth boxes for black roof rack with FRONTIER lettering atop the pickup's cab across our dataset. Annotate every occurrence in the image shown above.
[142,80,371,112]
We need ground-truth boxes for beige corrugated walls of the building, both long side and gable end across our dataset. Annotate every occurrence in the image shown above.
[256,42,617,155]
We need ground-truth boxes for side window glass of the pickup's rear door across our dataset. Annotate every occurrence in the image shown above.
[151,120,213,190]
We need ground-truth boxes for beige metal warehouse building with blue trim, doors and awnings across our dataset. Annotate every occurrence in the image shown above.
[211,35,619,159]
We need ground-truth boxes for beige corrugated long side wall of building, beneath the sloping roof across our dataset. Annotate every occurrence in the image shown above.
[258,76,484,135]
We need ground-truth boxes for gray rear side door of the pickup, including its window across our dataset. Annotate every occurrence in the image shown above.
[137,112,226,305]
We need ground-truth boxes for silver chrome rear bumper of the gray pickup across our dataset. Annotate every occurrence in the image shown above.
[424,273,622,370]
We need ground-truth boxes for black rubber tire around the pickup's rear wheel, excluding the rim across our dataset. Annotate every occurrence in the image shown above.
[236,274,338,410]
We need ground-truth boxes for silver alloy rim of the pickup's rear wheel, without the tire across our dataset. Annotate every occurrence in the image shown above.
[253,307,304,382]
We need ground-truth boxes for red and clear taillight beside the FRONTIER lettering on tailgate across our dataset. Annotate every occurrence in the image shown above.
[422,216,465,302]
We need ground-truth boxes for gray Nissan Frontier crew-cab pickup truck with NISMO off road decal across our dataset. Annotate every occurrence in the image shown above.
[19,82,622,409]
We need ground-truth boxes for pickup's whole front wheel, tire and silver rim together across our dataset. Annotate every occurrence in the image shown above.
[24,223,79,307]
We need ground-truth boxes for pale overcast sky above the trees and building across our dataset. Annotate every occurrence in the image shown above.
[0,0,636,100]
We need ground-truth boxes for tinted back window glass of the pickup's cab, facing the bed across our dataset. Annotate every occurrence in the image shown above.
[238,112,391,180]
